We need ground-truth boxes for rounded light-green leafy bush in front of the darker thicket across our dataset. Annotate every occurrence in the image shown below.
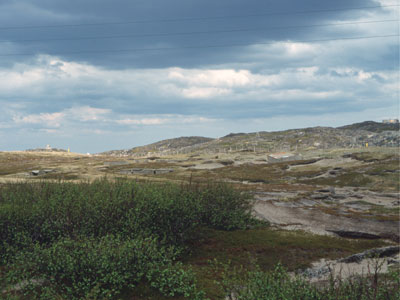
[8,235,202,299]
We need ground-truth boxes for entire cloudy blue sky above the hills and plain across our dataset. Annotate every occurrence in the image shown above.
[0,0,400,153]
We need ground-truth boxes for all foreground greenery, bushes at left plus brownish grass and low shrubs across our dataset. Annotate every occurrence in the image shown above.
[0,179,399,300]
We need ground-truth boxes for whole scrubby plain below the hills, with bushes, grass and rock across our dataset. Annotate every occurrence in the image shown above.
[0,148,399,300]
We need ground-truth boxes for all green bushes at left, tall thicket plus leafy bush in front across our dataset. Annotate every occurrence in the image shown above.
[0,179,254,299]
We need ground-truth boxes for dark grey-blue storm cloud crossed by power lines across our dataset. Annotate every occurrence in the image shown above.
[0,0,388,68]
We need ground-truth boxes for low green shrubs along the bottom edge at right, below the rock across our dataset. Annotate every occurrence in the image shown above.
[219,264,400,300]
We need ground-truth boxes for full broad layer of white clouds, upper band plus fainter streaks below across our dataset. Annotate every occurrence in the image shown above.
[0,41,398,137]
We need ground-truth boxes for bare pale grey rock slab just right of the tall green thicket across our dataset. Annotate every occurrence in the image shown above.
[254,187,400,243]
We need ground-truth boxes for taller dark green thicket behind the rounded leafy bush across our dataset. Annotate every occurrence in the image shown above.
[0,180,251,262]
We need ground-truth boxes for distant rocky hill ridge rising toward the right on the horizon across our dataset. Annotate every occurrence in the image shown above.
[103,121,400,156]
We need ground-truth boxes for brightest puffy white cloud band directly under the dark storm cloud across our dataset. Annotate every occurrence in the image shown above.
[0,53,396,106]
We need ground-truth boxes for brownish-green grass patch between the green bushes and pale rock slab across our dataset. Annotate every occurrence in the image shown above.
[184,228,386,299]
